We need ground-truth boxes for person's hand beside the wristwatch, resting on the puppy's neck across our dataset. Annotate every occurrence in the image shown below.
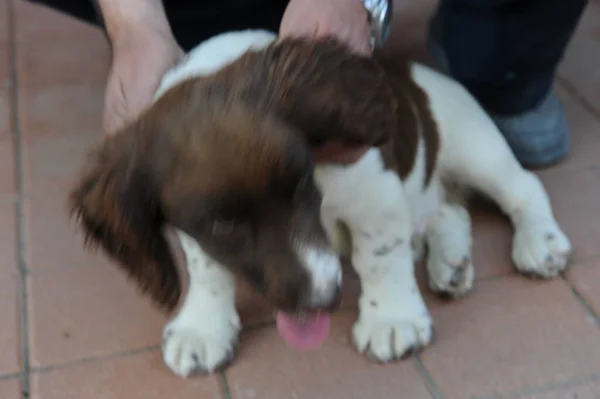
[279,0,372,55]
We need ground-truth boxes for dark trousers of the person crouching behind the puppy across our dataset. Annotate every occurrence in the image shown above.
[33,0,587,114]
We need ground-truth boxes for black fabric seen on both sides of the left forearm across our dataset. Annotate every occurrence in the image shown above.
[30,0,289,51]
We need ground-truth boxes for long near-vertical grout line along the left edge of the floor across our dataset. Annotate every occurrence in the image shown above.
[7,0,31,399]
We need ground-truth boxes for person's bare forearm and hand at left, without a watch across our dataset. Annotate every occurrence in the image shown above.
[93,0,183,134]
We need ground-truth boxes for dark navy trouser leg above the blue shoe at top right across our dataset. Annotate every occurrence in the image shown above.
[433,0,587,114]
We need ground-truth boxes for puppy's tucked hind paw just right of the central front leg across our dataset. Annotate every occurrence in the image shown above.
[427,255,475,299]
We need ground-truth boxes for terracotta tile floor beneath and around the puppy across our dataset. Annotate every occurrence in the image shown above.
[0,0,600,399]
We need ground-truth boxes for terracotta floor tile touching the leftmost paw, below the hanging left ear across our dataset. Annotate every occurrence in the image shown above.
[29,264,166,367]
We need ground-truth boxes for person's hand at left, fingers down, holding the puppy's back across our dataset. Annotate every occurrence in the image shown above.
[103,26,183,134]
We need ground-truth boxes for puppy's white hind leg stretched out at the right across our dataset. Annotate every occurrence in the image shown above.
[444,115,571,277]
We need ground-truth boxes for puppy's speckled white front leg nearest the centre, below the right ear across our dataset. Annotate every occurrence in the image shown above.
[317,157,433,362]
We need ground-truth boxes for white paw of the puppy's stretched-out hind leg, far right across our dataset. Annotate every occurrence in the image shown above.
[513,220,571,278]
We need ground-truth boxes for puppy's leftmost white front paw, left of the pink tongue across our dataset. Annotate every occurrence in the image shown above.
[163,314,240,378]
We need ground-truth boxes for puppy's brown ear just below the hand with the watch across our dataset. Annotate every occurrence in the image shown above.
[229,39,397,156]
